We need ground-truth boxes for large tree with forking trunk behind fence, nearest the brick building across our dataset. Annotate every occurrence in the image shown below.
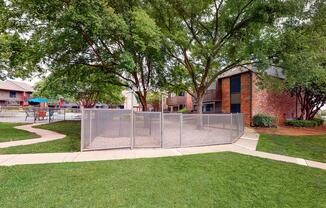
[151,0,301,113]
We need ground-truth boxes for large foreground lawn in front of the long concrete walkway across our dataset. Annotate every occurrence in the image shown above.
[0,152,326,208]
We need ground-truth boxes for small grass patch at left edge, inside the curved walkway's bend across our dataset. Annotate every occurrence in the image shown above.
[0,123,40,142]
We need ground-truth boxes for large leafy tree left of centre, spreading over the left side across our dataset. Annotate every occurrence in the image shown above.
[0,0,162,110]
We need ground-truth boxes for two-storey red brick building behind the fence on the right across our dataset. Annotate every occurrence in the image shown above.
[199,67,297,125]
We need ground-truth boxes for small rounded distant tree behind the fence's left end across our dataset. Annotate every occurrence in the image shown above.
[35,66,123,108]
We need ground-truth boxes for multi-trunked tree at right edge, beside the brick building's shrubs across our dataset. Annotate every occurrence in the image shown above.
[278,1,326,120]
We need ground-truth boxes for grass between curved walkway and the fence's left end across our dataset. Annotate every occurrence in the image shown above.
[0,121,80,154]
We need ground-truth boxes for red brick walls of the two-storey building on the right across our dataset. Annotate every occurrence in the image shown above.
[222,72,296,125]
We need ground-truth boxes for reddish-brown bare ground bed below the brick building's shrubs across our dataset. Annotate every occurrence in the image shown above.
[251,125,326,136]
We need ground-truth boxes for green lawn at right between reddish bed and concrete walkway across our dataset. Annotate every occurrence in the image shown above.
[257,134,326,162]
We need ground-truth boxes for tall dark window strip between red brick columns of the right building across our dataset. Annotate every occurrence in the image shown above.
[230,76,241,113]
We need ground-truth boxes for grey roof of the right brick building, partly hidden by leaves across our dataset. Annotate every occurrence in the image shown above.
[218,66,285,79]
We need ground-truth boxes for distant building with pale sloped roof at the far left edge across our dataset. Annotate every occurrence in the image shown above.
[0,80,34,106]
